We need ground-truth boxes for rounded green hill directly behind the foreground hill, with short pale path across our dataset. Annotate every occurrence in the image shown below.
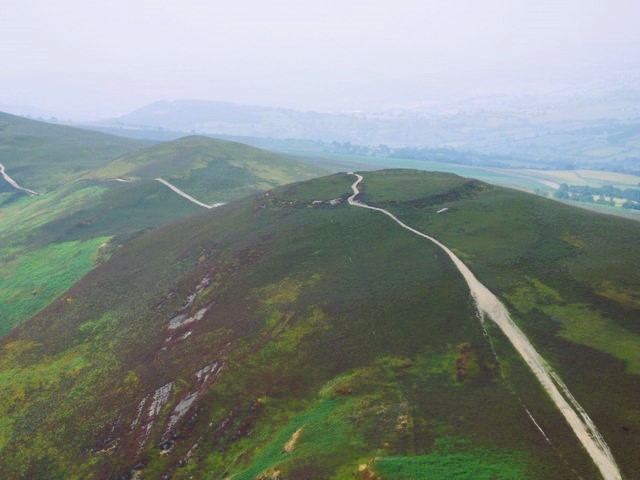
[0,128,321,335]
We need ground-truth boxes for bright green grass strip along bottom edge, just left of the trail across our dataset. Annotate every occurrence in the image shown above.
[374,450,528,480]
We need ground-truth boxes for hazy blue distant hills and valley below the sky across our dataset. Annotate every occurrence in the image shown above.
[93,96,640,173]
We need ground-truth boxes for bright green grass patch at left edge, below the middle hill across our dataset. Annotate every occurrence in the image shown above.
[0,237,110,334]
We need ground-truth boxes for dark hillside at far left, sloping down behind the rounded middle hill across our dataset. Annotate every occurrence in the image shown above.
[0,112,149,193]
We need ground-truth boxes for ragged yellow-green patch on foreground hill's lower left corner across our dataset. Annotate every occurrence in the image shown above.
[0,313,123,479]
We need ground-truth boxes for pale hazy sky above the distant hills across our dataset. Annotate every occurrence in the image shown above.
[0,0,640,118]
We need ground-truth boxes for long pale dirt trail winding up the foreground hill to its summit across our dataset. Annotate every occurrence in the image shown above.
[348,172,622,480]
